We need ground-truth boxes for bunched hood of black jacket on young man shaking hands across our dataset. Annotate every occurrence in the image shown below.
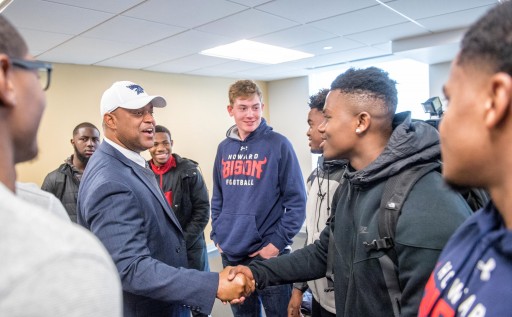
[345,111,441,185]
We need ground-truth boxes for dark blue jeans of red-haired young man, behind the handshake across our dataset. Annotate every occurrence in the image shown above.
[221,249,292,317]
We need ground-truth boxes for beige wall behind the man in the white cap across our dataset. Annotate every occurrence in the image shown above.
[17,64,268,189]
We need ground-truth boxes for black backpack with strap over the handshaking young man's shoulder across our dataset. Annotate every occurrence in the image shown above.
[364,162,490,316]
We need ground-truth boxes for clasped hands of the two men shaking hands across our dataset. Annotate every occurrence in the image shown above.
[217,265,256,304]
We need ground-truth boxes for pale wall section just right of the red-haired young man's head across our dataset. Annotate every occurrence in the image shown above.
[267,77,311,179]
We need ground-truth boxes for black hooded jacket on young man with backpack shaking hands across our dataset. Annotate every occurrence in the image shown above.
[251,113,471,317]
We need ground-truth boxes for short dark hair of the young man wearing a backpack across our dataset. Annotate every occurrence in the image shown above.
[331,67,398,117]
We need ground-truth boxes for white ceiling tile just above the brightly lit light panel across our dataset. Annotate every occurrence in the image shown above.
[197,9,297,39]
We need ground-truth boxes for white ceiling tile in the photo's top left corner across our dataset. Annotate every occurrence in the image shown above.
[2,0,114,35]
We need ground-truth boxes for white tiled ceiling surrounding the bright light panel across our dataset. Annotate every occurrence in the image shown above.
[3,0,497,81]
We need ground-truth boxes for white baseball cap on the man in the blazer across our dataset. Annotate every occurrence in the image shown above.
[100,81,167,117]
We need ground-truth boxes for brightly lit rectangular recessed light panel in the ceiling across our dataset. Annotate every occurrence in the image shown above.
[201,40,313,64]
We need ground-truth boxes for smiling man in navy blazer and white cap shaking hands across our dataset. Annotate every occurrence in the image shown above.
[78,81,254,317]
